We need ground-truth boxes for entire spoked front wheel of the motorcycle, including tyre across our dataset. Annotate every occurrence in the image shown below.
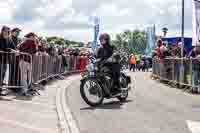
[80,79,104,106]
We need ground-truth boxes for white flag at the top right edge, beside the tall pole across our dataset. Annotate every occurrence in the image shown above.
[192,0,200,46]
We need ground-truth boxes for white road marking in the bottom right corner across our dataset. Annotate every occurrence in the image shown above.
[186,120,200,133]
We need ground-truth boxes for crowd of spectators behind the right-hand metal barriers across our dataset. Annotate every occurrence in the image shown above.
[153,38,200,92]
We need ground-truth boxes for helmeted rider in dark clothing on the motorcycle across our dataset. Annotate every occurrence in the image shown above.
[97,33,121,91]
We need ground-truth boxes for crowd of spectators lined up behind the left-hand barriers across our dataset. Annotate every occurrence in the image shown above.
[0,26,90,95]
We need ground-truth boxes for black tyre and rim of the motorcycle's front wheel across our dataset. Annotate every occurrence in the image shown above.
[80,79,104,107]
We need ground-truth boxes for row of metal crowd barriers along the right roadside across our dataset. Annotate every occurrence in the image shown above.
[152,58,200,92]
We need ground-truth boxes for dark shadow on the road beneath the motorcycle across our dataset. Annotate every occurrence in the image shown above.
[80,100,132,110]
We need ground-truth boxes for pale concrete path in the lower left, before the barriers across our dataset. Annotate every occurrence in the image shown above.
[0,79,59,133]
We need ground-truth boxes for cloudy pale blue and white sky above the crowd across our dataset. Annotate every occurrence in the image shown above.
[0,0,195,42]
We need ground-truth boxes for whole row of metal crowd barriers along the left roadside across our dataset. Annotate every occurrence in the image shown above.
[0,52,87,91]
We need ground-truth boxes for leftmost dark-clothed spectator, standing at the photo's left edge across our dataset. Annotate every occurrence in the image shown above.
[0,26,15,95]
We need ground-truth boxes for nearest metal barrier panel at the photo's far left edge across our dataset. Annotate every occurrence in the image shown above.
[0,51,32,88]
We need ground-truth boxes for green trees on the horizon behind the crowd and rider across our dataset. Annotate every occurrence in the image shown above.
[46,29,147,54]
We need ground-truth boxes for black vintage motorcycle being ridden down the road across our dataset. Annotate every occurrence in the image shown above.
[80,53,131,106]
